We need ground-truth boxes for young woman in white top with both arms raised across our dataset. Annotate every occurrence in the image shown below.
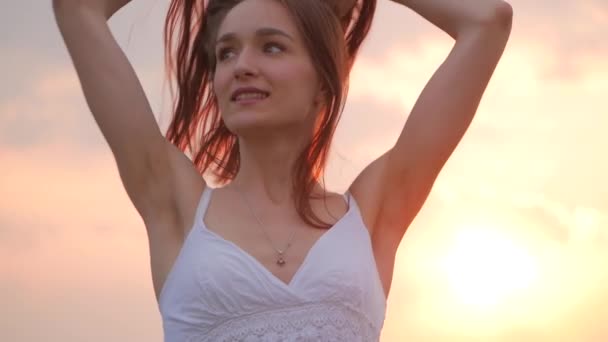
[53,0,512,341]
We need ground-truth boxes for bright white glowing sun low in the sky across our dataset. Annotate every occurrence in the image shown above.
[443,226,538,311]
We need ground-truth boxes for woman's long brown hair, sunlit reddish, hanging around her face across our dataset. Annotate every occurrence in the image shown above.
[164,0,377,228]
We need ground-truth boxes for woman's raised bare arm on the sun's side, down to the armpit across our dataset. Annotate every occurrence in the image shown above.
[350,0,513,250]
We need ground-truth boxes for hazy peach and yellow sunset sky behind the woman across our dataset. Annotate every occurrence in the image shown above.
[0,0,608,342]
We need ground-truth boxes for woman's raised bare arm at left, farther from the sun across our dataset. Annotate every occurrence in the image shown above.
[53,0,176,223]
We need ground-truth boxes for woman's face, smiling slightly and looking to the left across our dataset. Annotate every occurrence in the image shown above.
[213,0,320,134]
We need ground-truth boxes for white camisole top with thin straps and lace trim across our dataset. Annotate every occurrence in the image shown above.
[159,187,386,342]
